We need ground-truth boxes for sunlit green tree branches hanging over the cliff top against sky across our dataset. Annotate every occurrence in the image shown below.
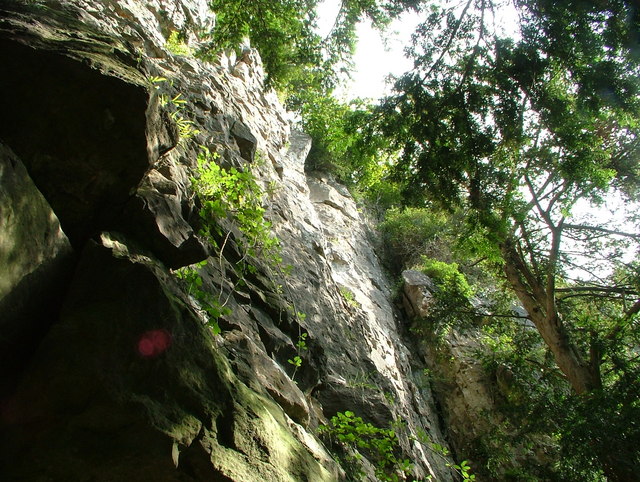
[205,0,421,92]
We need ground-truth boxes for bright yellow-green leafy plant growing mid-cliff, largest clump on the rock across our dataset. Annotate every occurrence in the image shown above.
[192,147,282,270]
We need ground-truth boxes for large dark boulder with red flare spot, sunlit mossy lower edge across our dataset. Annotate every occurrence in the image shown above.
[1,234,339,481]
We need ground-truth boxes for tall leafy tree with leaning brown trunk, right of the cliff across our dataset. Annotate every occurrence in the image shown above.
[372,0,640,480]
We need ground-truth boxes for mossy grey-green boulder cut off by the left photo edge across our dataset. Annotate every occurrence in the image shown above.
[0,144,74,397]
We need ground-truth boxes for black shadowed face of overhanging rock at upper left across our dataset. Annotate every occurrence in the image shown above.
[0,40,150,247]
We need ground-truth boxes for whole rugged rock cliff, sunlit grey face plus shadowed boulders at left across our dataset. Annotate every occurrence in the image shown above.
[0,0,454,481]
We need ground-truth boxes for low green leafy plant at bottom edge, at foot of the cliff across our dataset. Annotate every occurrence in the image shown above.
[318,411,413,482]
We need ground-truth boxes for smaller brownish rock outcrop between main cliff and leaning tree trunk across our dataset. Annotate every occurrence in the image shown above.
[402,270,555,480]
